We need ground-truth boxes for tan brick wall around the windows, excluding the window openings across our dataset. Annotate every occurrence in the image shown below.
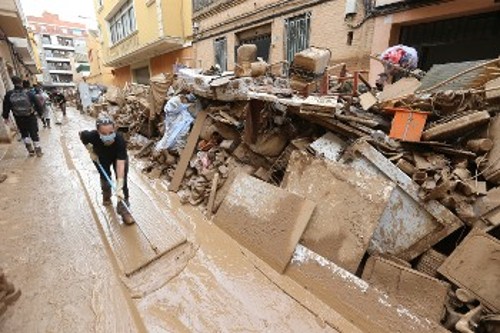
[193,0,374,70]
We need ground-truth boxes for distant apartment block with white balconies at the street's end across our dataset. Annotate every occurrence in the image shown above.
[28,12,88,88]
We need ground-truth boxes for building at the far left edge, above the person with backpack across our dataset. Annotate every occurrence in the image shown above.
[0,0,40,97]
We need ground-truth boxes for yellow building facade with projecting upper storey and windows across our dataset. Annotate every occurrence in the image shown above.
[94,0,193,86]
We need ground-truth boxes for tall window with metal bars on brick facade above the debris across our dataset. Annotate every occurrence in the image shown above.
[285,13,311,63]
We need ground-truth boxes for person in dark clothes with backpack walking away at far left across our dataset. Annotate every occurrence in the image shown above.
[2,76,43,157]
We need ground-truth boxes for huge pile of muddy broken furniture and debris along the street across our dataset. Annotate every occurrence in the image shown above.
[90,50,500,332]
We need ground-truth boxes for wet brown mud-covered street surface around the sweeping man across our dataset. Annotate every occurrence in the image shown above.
[0,110,344,332]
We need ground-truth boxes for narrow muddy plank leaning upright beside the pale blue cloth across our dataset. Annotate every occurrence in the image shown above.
[168,110,208,192]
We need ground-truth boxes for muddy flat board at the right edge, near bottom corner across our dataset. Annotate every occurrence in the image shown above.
[438,229,500,312]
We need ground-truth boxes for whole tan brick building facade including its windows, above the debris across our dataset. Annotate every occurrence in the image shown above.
[193,0,373,70]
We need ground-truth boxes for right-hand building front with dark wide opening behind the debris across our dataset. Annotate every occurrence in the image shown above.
[370,0,500,80]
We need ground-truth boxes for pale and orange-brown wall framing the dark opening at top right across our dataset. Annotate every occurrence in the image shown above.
[370,0,500,82]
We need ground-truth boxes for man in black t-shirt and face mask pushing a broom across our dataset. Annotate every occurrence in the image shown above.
[80,116,135,224]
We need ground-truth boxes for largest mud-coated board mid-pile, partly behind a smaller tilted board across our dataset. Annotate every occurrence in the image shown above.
[283,151,394,273]
